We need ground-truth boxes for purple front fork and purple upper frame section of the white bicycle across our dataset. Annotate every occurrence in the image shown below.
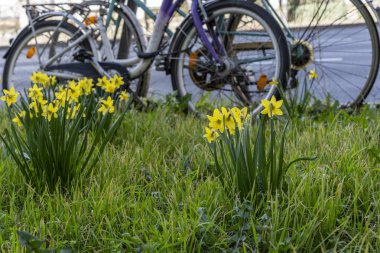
[156,0,224,63]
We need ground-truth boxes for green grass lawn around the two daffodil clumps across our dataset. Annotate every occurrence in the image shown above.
[0,105,380,252]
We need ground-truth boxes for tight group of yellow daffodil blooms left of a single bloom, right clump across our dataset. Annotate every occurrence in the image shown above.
[203,107,250,143]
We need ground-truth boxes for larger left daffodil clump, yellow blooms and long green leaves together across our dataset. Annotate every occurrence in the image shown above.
[0,73,131,192]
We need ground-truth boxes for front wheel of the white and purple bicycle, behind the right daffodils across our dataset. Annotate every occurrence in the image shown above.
[171,1,290,113]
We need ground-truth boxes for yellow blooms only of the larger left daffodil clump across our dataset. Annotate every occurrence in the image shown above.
[0,72,129,128]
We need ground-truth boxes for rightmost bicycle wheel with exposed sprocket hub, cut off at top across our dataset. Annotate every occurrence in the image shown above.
[274,0,380,107]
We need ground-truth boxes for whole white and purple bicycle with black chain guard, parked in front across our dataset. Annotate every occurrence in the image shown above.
[4,0,290,112]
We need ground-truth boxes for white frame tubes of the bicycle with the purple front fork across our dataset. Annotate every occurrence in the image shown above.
[24,0,189,79]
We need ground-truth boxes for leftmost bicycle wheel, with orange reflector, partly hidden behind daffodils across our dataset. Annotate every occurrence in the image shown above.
[3,20,89,91]
